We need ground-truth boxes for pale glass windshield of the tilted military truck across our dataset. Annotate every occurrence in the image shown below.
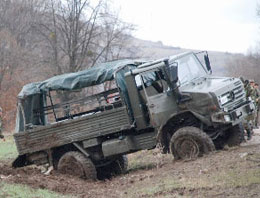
[176,54,207,85]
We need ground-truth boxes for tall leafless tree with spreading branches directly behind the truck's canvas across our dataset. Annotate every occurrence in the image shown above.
[35,0,136,74]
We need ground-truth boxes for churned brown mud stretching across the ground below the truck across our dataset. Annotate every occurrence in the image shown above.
[0,130,260,198]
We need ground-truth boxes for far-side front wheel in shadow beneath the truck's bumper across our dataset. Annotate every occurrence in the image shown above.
[225,123,245,147]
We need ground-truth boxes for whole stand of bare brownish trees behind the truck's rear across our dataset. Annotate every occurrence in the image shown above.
[0,0,136,129]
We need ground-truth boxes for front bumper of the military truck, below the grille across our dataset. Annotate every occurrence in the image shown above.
[211,101,255,125]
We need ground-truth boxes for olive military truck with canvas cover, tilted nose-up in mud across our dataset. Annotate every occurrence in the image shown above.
[13,52,254,179]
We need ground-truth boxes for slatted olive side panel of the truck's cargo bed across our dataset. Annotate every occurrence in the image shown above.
[14,106,131,155]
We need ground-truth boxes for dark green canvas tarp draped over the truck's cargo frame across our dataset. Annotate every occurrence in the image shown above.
[16,59,141,132]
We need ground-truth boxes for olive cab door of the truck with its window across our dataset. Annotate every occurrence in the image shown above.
[136,69,177,127]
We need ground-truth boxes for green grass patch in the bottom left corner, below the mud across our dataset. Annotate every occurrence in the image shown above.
[0,182,69,198]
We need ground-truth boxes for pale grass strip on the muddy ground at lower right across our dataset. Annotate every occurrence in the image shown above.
[128,169,260,198]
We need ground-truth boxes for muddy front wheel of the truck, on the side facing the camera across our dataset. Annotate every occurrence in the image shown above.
[170,127,215,160]
